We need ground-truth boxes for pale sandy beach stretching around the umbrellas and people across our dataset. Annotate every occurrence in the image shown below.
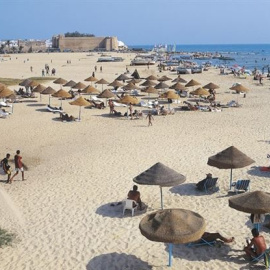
[0,53,270,270]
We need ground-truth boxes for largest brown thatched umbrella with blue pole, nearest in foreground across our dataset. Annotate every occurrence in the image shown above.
[139,209,206,267]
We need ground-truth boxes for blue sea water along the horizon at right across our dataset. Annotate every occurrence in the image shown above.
[129,44,270,72]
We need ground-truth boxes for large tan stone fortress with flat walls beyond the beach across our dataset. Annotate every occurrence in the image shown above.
[52,35,118,51]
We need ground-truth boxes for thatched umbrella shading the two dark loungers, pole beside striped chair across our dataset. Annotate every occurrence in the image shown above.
[207,146,255,189]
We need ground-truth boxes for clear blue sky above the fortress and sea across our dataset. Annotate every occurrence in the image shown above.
[0,0,270,45]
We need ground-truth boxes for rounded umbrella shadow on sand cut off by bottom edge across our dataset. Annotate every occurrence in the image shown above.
[86,252,152,270]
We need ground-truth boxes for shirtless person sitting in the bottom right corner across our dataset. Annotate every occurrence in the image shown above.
[244,228,266,259]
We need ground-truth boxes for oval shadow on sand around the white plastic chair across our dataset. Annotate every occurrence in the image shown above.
[96,201,148,218]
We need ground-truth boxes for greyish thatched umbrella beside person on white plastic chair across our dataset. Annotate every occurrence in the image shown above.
[133,162,186,209]
